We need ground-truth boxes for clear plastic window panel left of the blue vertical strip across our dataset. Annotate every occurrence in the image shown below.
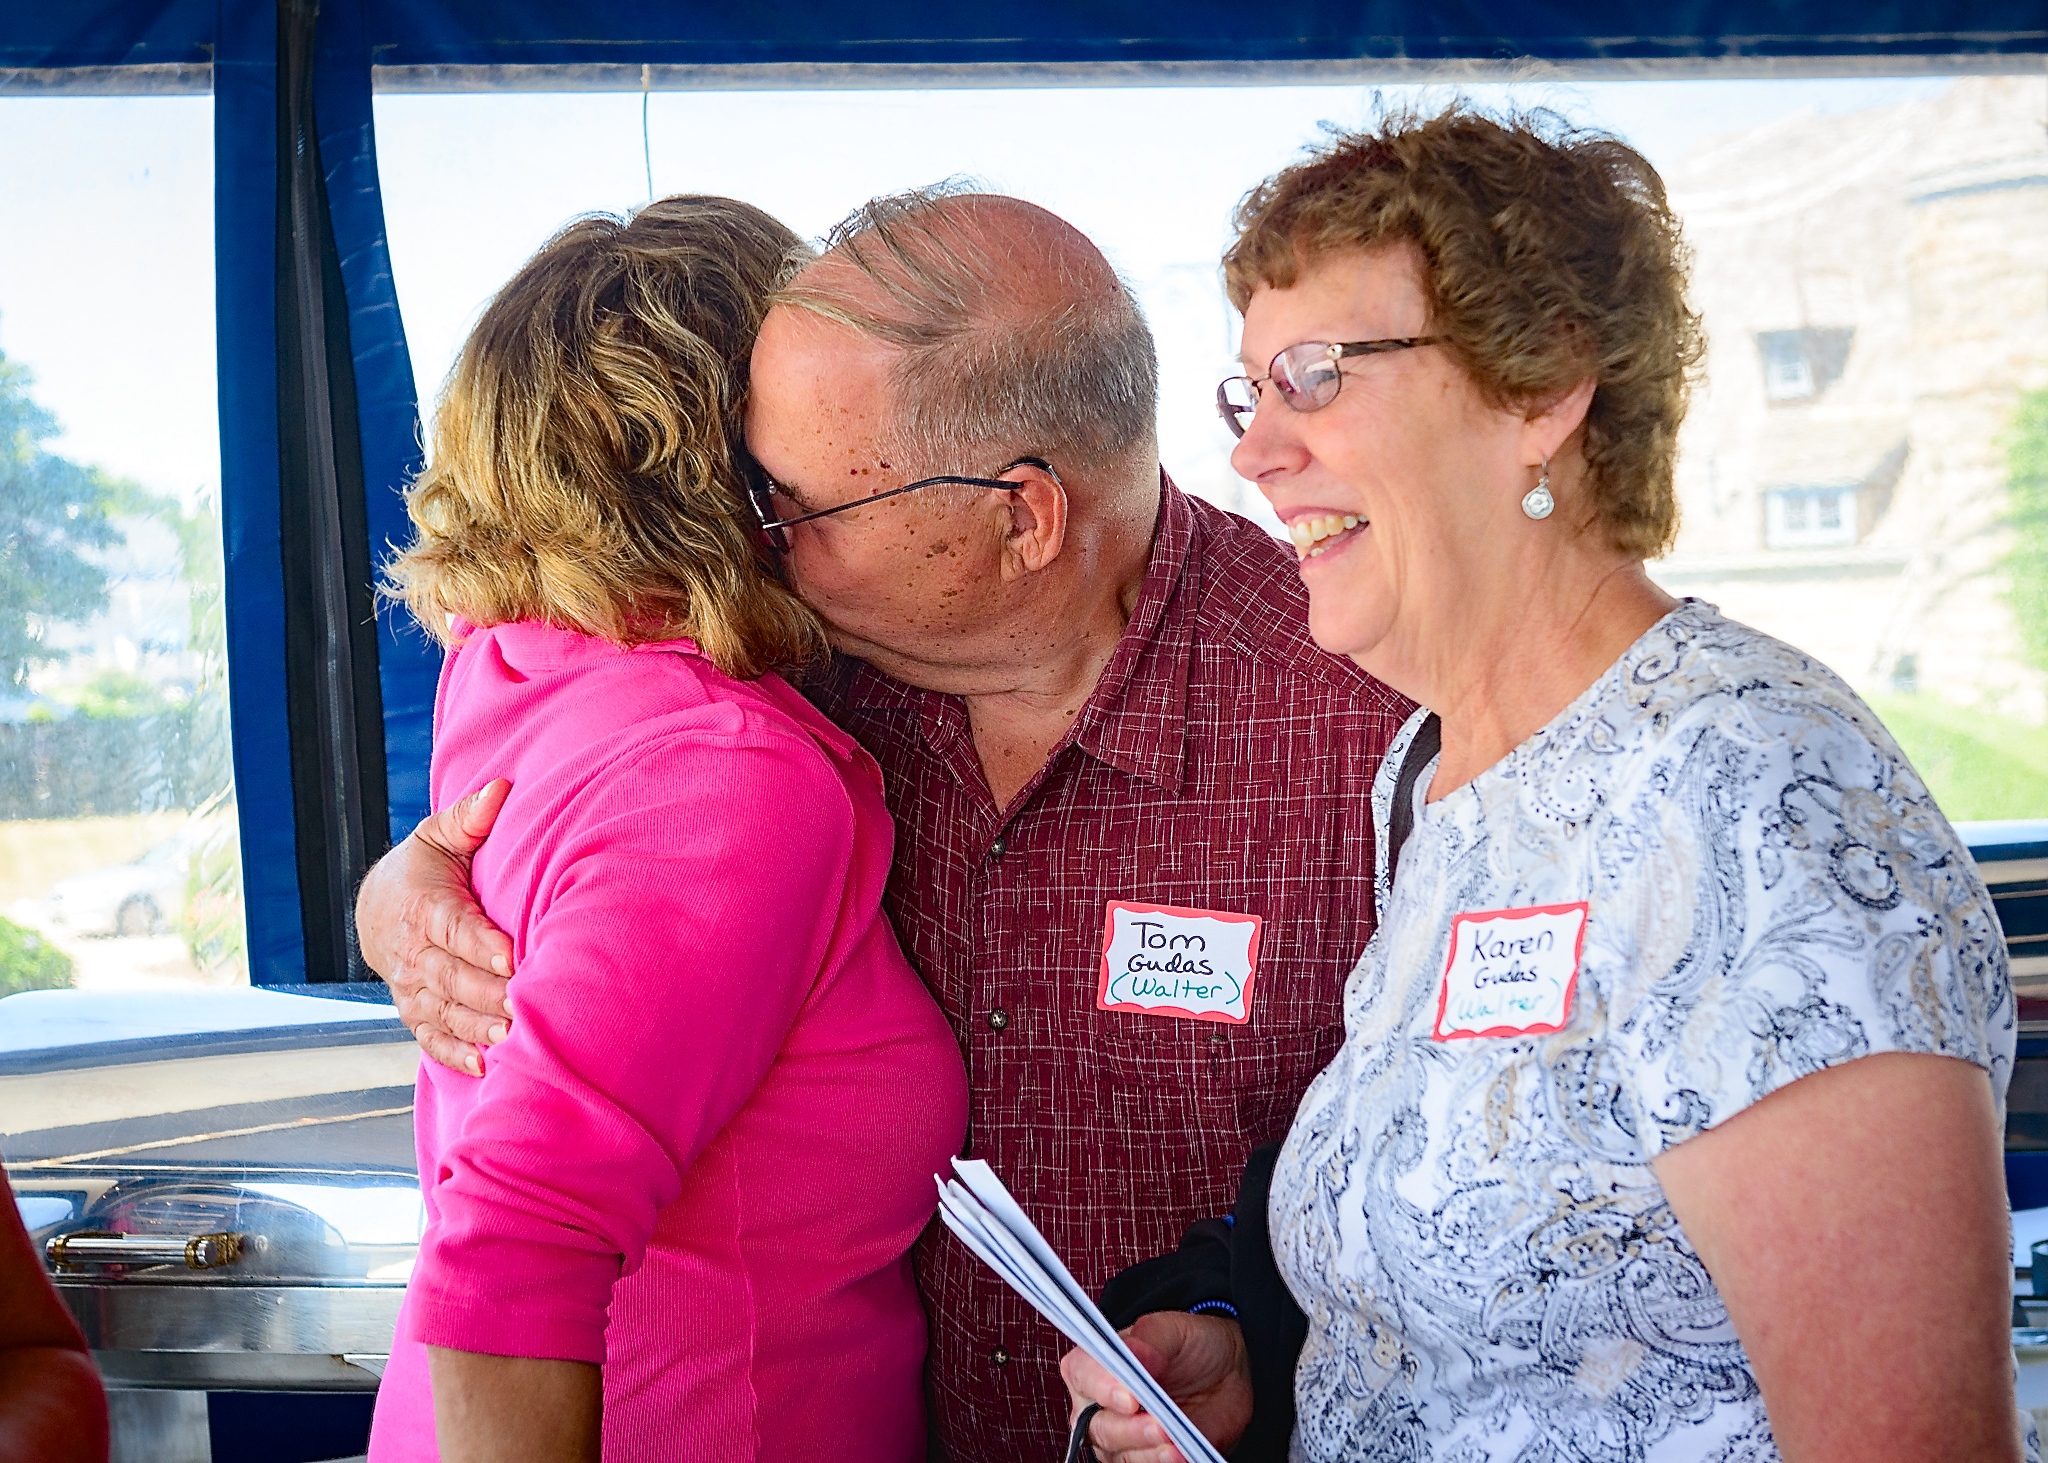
[0,94,248,996]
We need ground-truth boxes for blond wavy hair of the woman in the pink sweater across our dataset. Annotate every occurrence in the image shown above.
[385,195,825,678]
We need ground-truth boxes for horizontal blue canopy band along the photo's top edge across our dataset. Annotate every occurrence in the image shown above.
[12,0,2048,68]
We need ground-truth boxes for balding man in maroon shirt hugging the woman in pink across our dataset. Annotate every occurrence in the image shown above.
[358,195,1409,1463]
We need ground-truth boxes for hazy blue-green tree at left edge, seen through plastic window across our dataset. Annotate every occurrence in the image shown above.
[0,354,121,691]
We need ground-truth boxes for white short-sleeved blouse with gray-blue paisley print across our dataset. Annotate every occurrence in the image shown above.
[1270,600,2038,1463]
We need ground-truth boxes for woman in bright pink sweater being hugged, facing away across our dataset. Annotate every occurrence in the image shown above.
[371,199,967,1463]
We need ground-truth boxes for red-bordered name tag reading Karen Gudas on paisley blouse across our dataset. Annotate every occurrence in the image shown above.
[1430,900,1587,1041]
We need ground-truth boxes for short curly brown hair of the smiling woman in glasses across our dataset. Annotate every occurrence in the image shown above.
[1223,105,1704,559]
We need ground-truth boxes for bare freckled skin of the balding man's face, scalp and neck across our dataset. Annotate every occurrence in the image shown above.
[748,195,1159,805]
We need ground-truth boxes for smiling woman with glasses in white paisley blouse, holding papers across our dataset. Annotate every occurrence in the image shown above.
[1067,109,2036,1463]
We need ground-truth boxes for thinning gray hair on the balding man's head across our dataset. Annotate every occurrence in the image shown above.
[774,182,1159,473]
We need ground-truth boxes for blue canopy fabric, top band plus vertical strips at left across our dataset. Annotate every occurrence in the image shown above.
[0,0,2048,986]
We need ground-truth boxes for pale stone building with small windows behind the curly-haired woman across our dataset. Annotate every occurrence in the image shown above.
[1651,76,2048,723]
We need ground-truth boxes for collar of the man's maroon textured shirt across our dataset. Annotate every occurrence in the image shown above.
[844,469,1198,803]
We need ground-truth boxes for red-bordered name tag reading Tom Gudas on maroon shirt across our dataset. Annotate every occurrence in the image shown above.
[1096,900,1260,1027]
